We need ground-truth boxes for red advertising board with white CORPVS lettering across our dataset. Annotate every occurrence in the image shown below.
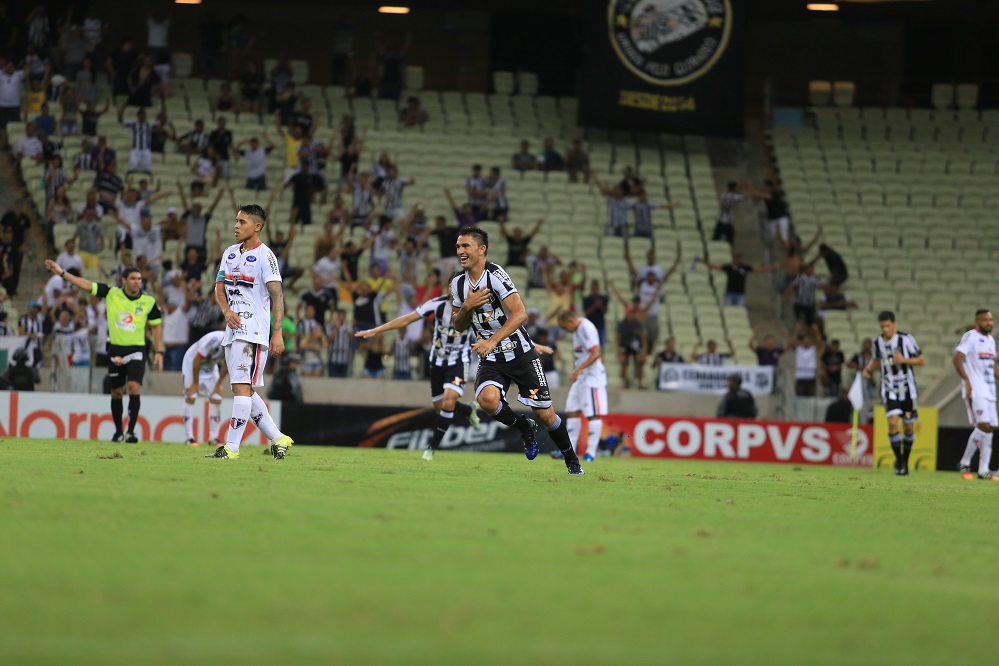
[604,414,873,467]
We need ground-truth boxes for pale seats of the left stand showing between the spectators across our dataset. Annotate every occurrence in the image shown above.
[11,63,750,387]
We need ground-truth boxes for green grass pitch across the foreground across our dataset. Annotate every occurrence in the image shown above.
[0,440,999,665]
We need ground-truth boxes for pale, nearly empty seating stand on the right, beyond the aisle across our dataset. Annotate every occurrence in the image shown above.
[772,101,999,385]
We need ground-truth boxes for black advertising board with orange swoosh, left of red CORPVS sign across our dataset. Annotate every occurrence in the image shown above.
[281,402,555,453]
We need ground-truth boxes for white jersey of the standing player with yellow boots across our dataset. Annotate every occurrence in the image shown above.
[215,243,281,348]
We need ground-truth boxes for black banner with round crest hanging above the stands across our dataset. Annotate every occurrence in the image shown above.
[579,0,749,136]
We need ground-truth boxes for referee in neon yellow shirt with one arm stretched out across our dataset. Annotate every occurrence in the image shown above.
[45,259,163,444]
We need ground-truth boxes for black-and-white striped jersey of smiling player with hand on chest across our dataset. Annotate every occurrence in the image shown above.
[451,261,534,363]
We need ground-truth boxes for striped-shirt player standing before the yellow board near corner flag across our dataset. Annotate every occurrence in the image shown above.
[862,310,926,476]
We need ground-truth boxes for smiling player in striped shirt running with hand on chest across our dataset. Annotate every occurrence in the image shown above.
[451,227,583,474]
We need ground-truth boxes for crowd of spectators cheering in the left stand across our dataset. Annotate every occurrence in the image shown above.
[0,6,884,410]
